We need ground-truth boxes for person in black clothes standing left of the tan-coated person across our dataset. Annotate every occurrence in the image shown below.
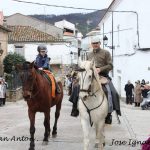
[124,80,134,105]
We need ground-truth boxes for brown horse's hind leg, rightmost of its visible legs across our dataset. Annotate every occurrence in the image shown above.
[52,101,61,137]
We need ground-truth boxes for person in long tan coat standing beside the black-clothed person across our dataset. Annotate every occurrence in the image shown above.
[134,80,142,107]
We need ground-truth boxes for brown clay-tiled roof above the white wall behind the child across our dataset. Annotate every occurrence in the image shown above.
[8,26,63,43]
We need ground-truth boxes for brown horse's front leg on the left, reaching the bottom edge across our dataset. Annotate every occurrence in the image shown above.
[28,110,35,150]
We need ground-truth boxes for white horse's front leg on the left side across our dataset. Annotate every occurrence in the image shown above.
[81,118,90,150]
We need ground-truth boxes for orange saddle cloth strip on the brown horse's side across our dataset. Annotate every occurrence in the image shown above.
[43,70,56,98]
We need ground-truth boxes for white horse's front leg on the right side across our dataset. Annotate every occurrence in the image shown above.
[95,120,105,150]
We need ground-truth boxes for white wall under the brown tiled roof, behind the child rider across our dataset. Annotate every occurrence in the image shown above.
[8,44,77,64]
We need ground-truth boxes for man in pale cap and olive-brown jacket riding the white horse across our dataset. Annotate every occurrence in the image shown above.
[87,37,121,124]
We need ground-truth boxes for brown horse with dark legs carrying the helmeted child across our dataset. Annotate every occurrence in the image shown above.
[17,62,63,150]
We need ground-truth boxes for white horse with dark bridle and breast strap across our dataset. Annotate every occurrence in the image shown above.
[78,61,108,150]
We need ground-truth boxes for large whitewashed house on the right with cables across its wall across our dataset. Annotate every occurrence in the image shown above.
[99,0,150,97]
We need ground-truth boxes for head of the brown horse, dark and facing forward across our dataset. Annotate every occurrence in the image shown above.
[16,62,36,100]
